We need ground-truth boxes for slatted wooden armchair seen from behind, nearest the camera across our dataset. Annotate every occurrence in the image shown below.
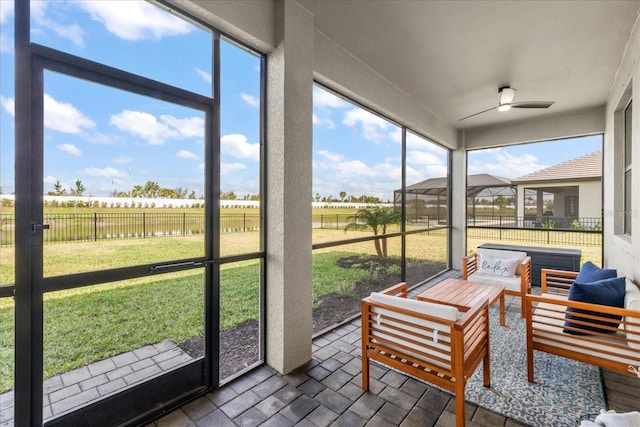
[362,283,491,427]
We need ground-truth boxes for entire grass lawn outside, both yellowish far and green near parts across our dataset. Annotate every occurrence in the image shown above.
[0,230,600,392]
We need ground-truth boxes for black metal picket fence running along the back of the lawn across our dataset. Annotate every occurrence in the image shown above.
[0,212,602,246]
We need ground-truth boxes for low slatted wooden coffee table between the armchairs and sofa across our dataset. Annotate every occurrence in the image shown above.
[416,279,504,326]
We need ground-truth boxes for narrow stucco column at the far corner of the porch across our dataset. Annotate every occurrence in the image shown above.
[451,148,467,269]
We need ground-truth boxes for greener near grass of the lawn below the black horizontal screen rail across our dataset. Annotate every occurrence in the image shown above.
[0,244,373,392]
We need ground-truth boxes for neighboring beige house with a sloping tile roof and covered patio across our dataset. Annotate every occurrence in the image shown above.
[511,151,602,223]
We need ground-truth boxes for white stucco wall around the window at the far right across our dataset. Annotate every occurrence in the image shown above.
[603,13,640,283]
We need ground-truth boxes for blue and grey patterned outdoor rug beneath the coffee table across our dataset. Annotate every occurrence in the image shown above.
[372,305,605,427]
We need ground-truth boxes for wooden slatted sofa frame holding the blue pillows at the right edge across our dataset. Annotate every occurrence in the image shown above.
[525,269,640,382]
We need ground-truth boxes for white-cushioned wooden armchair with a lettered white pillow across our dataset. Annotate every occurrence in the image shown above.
[462,248,531,317]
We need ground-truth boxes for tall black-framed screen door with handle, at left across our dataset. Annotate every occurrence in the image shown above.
[16,46,219,425]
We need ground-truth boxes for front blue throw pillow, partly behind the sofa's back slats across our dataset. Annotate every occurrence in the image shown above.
[563,277,625,335]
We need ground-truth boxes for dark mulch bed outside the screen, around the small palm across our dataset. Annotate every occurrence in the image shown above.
[180,255,446,379]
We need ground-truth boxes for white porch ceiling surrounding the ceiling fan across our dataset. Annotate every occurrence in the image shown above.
[299,0,640,128]
